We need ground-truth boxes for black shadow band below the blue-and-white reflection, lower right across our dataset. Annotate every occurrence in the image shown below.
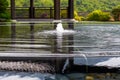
[65,65,120,73]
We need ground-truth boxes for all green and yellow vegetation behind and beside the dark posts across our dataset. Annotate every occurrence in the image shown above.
[0,0,120,21]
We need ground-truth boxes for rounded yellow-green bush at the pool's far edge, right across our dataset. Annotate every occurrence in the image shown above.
[87,10,111,21]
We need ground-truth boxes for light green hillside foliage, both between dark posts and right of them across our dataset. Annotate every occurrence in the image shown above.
[6,0,120,12]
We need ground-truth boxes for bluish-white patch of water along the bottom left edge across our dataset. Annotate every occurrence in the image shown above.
[0,71,54,80]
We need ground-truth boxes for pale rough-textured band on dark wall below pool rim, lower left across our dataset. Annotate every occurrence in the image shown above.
[0,61,55,73]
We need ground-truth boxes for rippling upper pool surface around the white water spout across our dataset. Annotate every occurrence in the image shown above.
[0,24,120,53]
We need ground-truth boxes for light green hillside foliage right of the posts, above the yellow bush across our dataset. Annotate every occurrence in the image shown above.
[75,0,120,12]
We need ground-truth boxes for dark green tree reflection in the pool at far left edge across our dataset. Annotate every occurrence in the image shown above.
[0,26,10,38]
